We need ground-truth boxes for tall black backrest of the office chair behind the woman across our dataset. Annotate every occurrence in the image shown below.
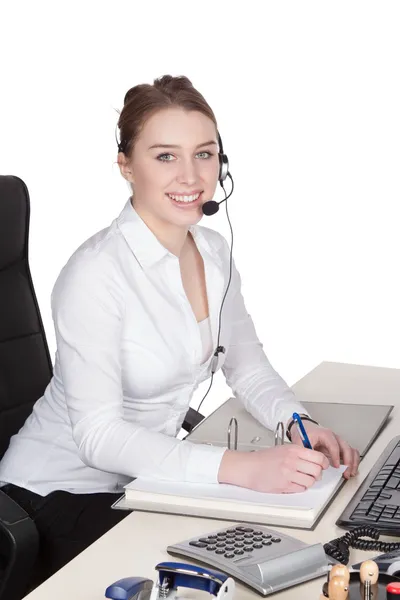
[0,175,53,459]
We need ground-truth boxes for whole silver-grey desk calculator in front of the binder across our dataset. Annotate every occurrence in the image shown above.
[167,523,330,596]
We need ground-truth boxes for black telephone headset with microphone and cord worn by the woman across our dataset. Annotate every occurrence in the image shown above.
[115,131,235,412]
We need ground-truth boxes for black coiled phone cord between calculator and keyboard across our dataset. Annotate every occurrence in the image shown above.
[324,525,400,565]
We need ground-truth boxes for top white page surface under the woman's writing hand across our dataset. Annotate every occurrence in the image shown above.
[125,465,347,510]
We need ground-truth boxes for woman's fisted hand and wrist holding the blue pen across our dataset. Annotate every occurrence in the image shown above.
[218,444,329,494]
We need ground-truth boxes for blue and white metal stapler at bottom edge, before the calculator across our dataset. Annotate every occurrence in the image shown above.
[105,562,235,600]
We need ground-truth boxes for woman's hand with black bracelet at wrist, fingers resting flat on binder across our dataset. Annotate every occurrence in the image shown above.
[290,420,360,479]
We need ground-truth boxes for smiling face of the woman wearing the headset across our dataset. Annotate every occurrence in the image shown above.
[118,107,219,230]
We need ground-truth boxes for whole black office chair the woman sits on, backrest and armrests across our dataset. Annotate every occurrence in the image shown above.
[0,175,204,600]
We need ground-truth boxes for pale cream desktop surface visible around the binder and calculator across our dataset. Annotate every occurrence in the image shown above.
[26,362,400,600]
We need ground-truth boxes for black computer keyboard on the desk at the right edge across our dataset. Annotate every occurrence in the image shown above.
[336,435,400,537]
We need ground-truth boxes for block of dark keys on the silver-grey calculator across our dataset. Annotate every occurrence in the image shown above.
[189,526,281,558]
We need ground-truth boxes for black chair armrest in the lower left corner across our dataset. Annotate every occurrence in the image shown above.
[0,489,39,600]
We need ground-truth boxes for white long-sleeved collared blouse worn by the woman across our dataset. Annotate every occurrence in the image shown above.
[0,199,306,495]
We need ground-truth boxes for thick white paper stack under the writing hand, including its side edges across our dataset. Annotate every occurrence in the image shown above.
[113,465,346,529]
